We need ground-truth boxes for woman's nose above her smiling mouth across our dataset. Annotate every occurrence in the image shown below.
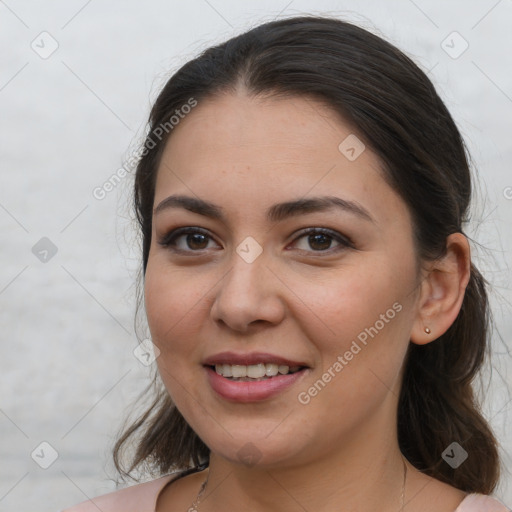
[211,253,286,332]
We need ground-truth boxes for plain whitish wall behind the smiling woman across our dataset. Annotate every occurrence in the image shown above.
[0,0,512,512]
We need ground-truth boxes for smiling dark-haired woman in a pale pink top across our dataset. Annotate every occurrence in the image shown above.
[63,17,507,512]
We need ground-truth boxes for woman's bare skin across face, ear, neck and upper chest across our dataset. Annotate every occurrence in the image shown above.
[145,89,469,512]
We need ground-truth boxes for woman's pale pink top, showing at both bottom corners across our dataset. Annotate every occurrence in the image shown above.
[61,474,510,512]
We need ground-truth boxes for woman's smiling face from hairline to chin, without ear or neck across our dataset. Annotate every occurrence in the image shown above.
[145,92,424,467]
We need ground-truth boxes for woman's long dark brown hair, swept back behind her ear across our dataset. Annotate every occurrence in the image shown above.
[114,16,499,493]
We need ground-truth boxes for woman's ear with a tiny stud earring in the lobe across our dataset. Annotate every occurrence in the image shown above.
[411,233,471,345]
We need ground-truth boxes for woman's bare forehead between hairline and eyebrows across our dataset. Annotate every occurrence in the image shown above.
[155,92,408,230]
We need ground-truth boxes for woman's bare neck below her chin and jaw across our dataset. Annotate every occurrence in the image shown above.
[199,418,404,512]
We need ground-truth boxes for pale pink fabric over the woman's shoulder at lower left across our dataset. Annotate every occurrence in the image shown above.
[62,474,178,512]
